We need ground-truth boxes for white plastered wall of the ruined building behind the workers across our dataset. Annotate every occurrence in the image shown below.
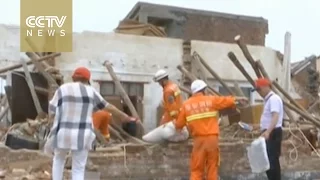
[0,25,281,130]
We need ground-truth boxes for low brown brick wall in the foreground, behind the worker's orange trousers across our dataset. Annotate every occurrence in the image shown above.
[91,143,249,180]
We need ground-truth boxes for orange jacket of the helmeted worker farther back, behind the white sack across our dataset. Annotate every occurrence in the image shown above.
[161,81,182,124]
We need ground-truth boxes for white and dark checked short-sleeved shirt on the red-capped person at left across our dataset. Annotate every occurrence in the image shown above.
[49,82,108,150]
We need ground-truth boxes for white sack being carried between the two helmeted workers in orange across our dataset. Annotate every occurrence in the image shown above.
[142,121,189,143]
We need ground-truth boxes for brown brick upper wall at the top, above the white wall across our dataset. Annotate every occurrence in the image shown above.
[183,14,268,46]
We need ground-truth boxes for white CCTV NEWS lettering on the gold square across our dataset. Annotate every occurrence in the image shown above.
[26,16,67,37]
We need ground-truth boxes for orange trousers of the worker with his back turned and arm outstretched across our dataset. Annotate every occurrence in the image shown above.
[190,135,220,180]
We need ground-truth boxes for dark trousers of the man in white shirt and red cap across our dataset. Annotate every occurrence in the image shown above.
[266,128,282,180]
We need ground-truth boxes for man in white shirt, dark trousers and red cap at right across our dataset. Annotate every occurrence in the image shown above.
[255,78,283,180]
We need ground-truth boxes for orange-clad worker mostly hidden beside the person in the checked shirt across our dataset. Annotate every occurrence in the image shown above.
[92,110,112,140]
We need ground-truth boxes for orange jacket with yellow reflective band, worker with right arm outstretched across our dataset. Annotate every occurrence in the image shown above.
[175,93,235,137]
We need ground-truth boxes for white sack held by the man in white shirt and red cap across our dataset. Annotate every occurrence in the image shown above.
[247,137,270,173]
